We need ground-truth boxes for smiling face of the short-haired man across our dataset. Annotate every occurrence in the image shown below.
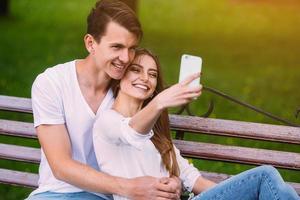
[93,22,138,79]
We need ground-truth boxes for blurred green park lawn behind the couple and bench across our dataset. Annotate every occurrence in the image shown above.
[0,0,300,199]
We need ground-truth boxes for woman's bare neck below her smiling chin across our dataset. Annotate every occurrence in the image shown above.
[112,91,143,117]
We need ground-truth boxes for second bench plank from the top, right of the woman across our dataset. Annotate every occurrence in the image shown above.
[174,140,300,170]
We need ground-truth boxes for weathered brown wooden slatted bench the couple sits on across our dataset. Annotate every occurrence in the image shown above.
[0,95,300,194]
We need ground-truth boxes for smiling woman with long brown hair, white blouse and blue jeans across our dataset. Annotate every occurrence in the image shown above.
[93,49,299,200]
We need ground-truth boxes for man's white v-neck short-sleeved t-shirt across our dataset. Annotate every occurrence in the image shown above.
[31,61,114,198]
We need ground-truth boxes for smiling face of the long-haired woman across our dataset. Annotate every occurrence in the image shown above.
[120,55,158,101]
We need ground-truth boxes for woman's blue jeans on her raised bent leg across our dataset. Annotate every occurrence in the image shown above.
[193,166,300,200]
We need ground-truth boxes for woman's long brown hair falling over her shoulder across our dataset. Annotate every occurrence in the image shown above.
[112,49,180,176]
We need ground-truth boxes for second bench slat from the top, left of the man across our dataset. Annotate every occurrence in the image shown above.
[0,119,37,138]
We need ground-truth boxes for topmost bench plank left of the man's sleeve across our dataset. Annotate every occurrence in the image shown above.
[0,95,32,113]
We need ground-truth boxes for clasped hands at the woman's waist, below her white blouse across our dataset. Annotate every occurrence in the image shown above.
[125,176,181,200]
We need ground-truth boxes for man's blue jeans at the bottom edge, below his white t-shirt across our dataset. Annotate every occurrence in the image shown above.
[26,192,112,200]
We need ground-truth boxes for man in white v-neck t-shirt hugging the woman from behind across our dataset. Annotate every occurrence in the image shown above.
[28,0,200,200]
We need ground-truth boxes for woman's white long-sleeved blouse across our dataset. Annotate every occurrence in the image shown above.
[93,109,200,200]
